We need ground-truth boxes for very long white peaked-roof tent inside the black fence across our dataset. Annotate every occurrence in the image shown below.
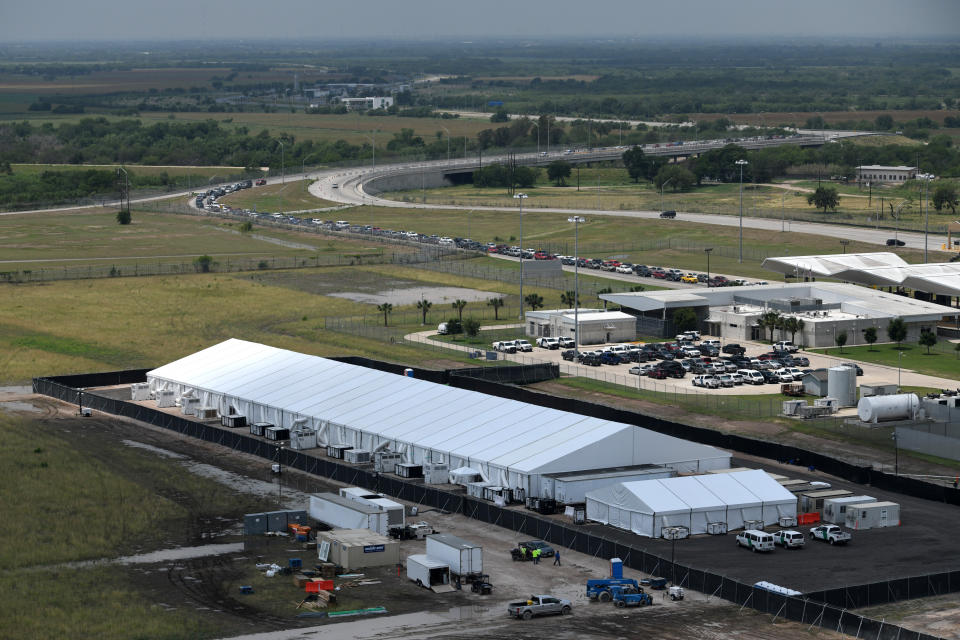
[147,339,730,497]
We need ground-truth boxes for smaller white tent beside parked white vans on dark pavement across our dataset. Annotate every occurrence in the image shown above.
[587,469,797,538]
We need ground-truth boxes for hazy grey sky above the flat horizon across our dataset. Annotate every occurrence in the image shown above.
[0,0,960,42]
